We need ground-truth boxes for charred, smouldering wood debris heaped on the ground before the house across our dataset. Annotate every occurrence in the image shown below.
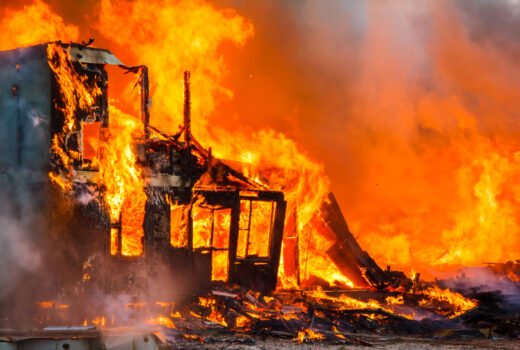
[72,270,520,348]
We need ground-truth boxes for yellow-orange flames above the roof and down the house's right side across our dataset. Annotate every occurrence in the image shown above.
[96,0,344,287]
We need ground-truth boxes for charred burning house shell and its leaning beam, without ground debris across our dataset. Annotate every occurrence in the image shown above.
[0,42,387,322]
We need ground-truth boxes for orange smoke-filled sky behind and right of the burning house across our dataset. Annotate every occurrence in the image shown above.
[0,0,520,274]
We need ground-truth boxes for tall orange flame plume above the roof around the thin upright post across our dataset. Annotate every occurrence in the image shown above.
[96,0,253,139]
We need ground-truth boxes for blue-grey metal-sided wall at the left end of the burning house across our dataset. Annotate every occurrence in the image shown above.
[0,45,52,219]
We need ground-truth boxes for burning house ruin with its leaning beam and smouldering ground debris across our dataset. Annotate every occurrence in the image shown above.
[0,42,518,348]
